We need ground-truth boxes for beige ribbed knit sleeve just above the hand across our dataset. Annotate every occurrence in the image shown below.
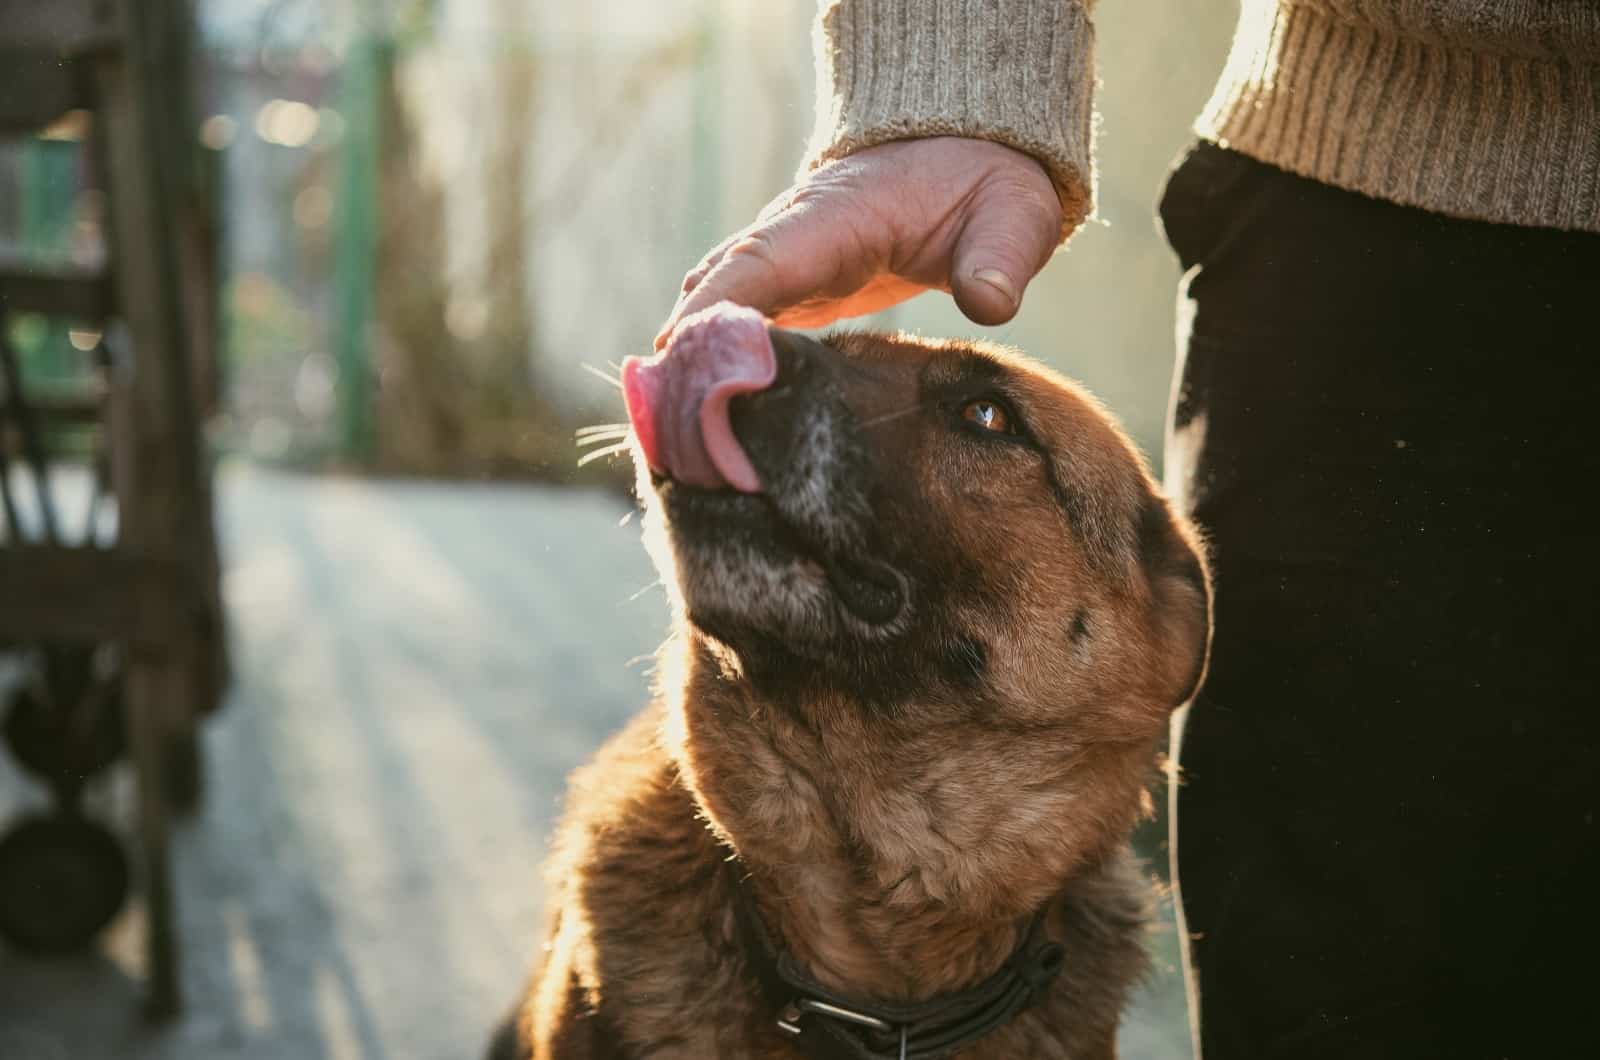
[802,0,1094,240]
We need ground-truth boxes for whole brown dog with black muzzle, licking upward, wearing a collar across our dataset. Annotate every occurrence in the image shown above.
[493,306,1210,1060]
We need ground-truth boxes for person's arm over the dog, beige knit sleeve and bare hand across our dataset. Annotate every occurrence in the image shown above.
[658,0,1094,344]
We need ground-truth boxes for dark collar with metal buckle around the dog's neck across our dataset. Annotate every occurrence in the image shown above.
[731,861,1066,1060]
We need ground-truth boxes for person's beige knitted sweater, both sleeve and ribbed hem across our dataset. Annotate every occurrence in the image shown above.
[806,0,1600,235]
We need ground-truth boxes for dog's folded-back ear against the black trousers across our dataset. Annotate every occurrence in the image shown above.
[1139,493,1211,708]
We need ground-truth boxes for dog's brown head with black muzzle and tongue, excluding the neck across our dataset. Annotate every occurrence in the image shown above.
[624,306,1208,741]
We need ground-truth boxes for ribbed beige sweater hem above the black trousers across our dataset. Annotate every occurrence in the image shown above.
[1197,0,1600,232]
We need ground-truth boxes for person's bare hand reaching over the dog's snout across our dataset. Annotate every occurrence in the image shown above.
[656,136,1062,349]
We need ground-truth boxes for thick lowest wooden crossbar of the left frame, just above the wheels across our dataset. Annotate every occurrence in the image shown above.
[0,541,184,648]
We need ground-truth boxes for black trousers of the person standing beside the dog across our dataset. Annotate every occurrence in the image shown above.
[1162,144,1600,1060]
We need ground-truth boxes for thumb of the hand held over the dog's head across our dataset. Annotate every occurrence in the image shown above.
[950,187,1061,325]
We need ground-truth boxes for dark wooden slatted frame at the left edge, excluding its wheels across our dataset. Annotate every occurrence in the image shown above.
[0,0,224,1017]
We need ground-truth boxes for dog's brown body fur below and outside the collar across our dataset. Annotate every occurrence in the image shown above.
[518,709,1146,1060]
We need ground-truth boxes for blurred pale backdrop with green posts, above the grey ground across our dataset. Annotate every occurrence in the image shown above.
[0,0,1235,482]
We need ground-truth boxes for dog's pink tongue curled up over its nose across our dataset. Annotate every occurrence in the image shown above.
[622,303,778,493]
